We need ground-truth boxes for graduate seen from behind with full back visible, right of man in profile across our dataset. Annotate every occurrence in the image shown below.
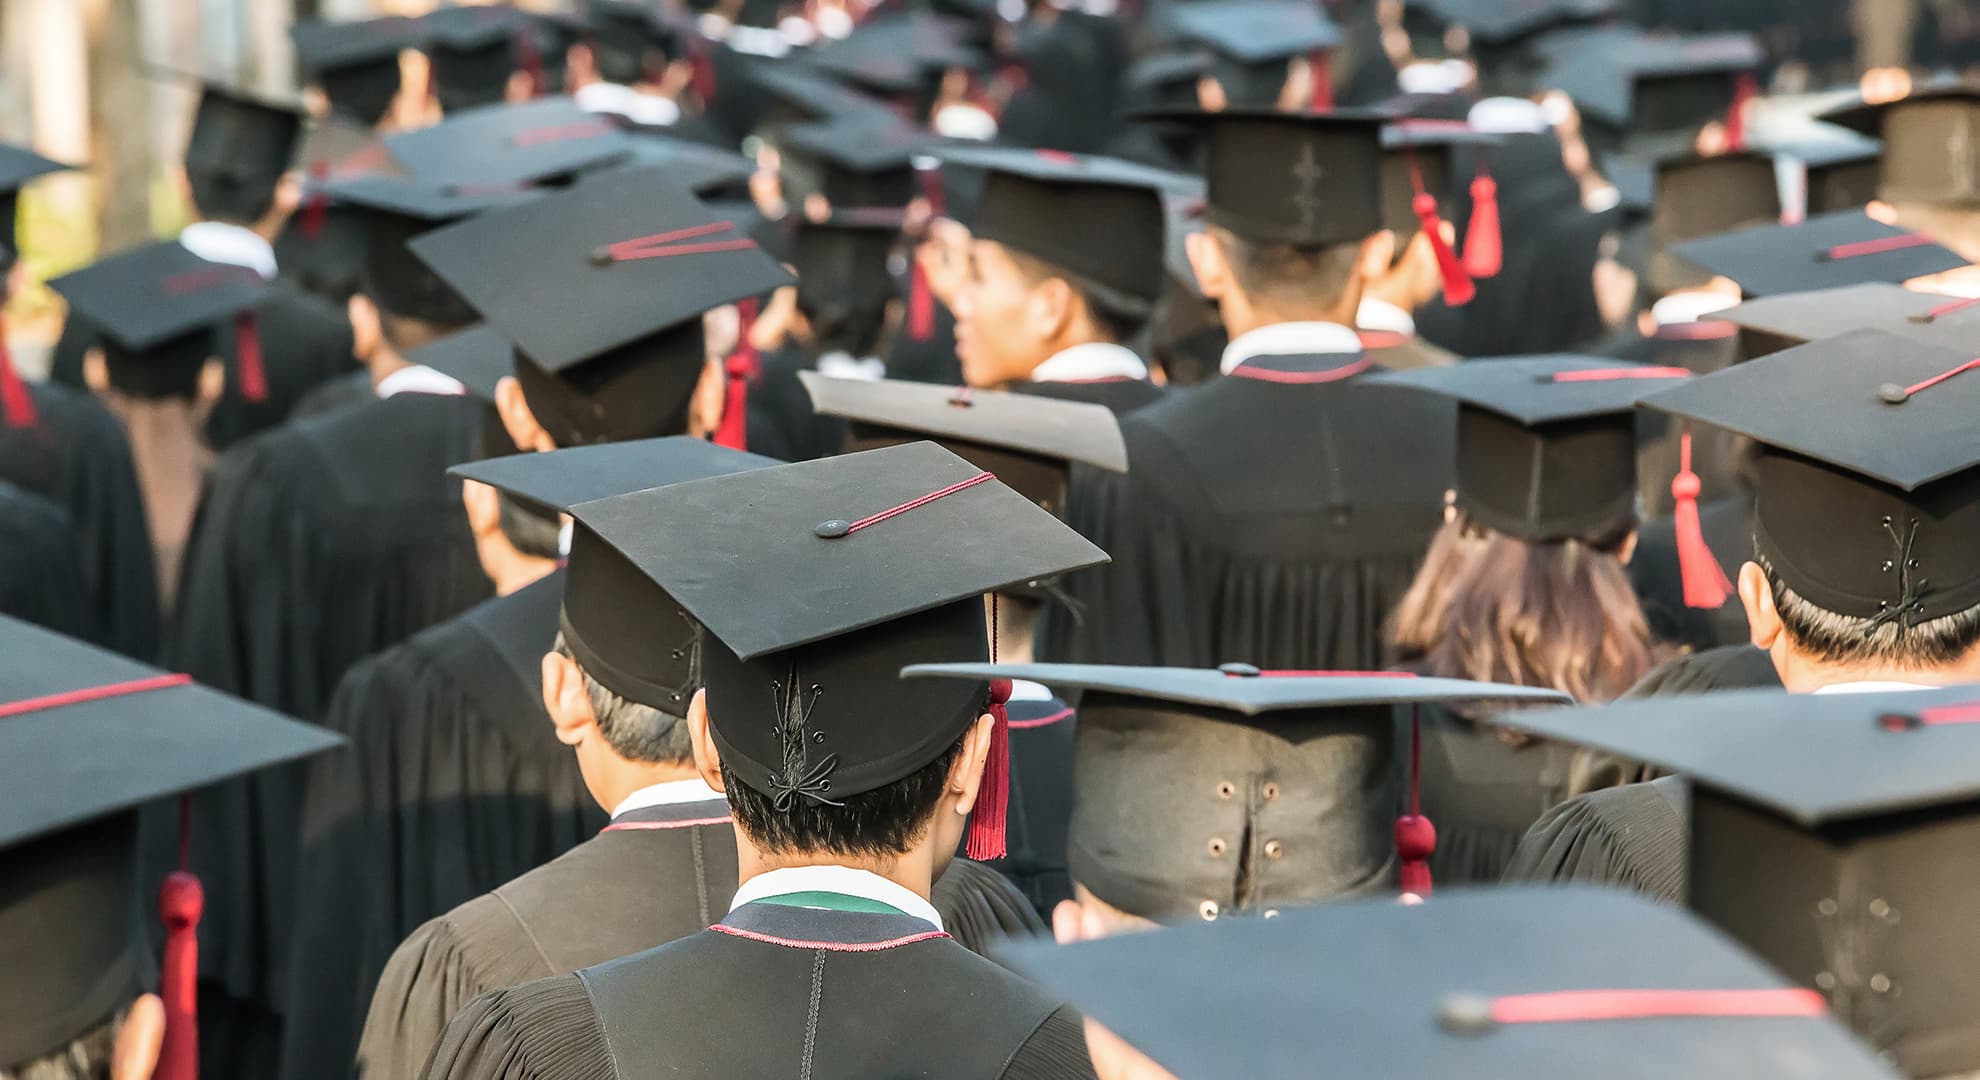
[1040,111,1455,670]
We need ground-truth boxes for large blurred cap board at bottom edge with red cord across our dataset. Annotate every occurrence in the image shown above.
[998,883,1895,1080]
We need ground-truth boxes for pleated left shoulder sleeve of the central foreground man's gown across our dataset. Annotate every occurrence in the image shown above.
[424,975,616,1080]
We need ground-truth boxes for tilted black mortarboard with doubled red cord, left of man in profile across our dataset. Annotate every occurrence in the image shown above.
[412,168,792,446]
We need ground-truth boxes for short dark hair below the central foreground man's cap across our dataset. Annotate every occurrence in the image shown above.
[723,733,968,858]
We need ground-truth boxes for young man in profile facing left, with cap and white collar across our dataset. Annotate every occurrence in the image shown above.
[942,149,1174,414]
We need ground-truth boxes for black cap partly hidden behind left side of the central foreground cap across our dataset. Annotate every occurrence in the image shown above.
[447,436,780,715]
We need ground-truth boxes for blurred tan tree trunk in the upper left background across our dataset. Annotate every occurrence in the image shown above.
[84,0,152,252]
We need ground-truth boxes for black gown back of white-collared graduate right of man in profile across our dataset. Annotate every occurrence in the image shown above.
[1040,355,1455,670]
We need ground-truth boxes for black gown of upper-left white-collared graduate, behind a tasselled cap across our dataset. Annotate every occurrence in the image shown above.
[50,279,356,450]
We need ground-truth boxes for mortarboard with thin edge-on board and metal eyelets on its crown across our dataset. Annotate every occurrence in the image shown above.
[903,664,1566,921]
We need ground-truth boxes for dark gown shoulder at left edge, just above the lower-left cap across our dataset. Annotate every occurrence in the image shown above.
[0,480,103,642]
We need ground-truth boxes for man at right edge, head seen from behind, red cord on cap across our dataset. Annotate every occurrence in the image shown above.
[1507,329,1980,902]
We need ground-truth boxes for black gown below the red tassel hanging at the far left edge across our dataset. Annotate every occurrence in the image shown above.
[0,382,158,662]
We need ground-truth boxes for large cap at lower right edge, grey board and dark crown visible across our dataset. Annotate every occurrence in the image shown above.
[1488,688,1980,1076]
